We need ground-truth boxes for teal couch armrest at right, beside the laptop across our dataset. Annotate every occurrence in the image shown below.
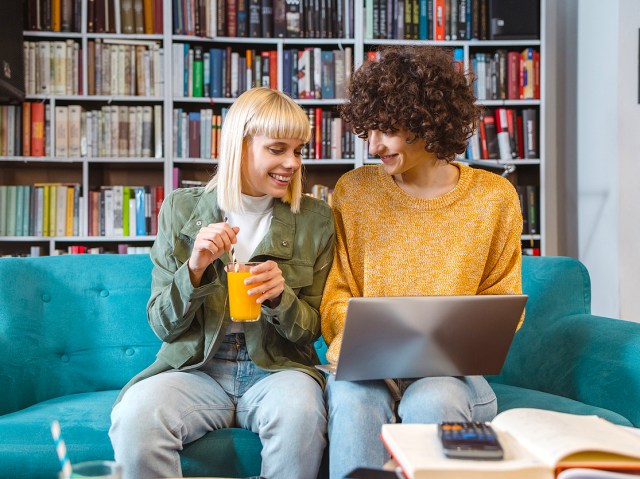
[492,314,640,426]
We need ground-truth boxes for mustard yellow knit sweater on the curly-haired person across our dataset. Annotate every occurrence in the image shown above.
[320,163,522,362]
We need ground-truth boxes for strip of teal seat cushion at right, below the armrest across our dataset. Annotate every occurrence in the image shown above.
[490,383,633,426]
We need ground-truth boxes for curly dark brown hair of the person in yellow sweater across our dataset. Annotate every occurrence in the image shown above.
[339,45,482,161]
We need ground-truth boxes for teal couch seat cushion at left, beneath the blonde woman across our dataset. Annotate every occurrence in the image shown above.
[0,390,262,479]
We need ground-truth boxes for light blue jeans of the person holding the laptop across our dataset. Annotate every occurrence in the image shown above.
[326,376,497,479]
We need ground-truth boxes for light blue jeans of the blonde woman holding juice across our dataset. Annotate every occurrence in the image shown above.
[109,334,327,479]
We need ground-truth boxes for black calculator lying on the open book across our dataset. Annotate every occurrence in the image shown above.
[438,422,504,461]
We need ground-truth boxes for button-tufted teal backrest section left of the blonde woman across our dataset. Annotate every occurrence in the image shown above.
[0,255,160,414]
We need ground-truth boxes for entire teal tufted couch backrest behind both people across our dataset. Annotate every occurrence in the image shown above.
[0,255,591,414]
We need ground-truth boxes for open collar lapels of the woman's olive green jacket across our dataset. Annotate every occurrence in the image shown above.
[180,188,296,262]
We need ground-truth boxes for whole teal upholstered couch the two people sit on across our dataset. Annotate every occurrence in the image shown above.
[0,255,640,479]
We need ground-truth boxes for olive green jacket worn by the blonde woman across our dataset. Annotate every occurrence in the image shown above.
[118,188,335,400]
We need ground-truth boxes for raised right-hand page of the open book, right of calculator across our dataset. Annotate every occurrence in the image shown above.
[491,408,640,467]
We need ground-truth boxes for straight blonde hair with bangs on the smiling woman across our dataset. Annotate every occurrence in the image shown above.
[206,87,311,213]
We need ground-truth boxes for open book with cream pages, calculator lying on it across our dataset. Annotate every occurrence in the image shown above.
[382,409,640,479]
